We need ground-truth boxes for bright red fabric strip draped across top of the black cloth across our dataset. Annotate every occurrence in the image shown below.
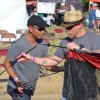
[67,51,100,69]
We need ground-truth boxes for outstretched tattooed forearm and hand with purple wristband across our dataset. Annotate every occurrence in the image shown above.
[17,53,63,66]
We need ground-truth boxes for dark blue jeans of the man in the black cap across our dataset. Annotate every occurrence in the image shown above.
[7,86,31,100]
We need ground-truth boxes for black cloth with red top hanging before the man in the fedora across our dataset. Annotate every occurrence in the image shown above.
[63,51,100,100]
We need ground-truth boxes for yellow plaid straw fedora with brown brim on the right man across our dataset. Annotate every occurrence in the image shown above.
[61,10,85,28]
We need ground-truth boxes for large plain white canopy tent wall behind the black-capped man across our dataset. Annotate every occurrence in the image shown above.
[0,0,28,33]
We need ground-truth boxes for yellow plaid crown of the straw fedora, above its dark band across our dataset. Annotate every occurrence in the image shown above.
[64,10,83,22]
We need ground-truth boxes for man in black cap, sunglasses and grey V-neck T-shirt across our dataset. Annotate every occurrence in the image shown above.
[4,15,48,100]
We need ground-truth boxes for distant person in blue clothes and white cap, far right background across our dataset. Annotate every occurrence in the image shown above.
[88,3,97,32]
